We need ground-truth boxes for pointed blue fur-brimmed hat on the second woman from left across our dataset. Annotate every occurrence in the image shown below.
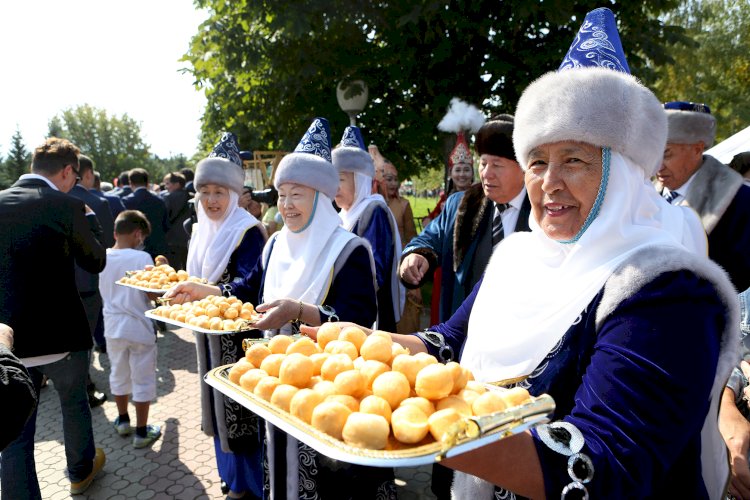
[273,118,339,200]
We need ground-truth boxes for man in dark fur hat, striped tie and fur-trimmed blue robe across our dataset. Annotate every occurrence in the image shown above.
[399,115,530,322]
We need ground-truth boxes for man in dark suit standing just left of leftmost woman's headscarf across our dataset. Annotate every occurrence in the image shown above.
[163,172,190,269]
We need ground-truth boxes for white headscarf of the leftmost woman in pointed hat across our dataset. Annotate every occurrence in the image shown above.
[187,190,260,283]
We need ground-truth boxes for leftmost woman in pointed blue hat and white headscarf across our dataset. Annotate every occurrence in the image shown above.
[187,133,266,497]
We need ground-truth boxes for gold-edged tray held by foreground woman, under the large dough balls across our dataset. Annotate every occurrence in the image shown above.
[204,365,555,467]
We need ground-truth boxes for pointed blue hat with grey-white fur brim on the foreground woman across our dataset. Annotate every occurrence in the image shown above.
[513,8,667,177]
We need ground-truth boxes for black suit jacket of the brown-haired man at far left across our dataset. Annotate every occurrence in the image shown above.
[0,179,106,358]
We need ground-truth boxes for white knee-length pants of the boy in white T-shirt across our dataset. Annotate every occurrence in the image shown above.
[107,338,156,403]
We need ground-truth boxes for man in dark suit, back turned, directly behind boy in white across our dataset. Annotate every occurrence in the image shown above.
[122,168,169,258]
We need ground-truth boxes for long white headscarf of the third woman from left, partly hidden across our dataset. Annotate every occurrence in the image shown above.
[339,172,406,322]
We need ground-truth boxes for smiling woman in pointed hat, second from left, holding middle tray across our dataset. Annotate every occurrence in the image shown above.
[167,118,395,498]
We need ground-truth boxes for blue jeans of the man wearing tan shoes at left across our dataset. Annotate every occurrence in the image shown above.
[0,351,96,500]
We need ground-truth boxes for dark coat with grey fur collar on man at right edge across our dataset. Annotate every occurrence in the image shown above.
[656,155,750,292]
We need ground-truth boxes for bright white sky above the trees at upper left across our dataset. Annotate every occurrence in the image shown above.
[0,0,207,158]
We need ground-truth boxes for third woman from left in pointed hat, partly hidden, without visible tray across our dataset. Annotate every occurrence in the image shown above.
[332,126,404,331]
